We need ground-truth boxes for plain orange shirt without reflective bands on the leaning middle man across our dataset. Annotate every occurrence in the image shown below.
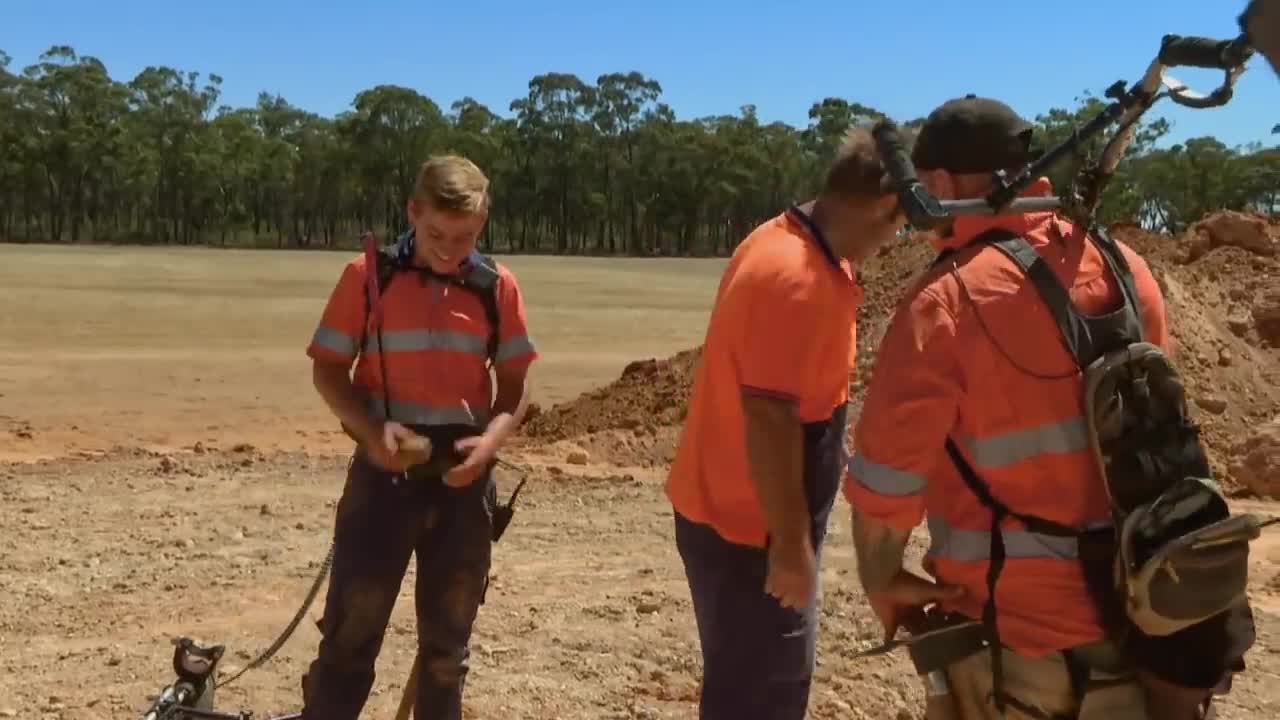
[667,208,861,547]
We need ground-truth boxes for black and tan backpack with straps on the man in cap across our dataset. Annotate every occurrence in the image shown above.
[934,222,1268,710]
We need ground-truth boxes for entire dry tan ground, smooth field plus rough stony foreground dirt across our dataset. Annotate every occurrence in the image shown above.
[0,245,1280,720]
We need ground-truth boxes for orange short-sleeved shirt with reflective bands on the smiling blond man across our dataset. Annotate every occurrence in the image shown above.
[307,254,538,429]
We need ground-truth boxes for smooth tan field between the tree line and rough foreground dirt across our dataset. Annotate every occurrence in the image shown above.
[0,245,723,460]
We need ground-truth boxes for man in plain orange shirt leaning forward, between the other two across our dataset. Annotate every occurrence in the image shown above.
[667,129,904,720]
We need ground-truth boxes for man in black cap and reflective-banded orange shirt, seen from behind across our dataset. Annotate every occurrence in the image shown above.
[844,95,1190,720]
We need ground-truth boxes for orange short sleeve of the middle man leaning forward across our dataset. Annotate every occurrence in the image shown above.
[733,272,831,404]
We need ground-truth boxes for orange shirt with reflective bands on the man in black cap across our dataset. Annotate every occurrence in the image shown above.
[845,178,1169,656]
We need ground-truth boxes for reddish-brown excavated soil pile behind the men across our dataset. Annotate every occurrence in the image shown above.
[522,213,1280,496]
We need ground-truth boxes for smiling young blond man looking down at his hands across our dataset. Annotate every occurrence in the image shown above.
[302,155,538,720]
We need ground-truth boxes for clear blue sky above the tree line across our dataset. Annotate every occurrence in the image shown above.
[0,0,1280,145]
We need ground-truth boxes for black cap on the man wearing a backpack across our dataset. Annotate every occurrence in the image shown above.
[911,95,1034,173]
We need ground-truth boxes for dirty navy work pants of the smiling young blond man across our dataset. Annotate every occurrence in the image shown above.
[302,451,495,720]
